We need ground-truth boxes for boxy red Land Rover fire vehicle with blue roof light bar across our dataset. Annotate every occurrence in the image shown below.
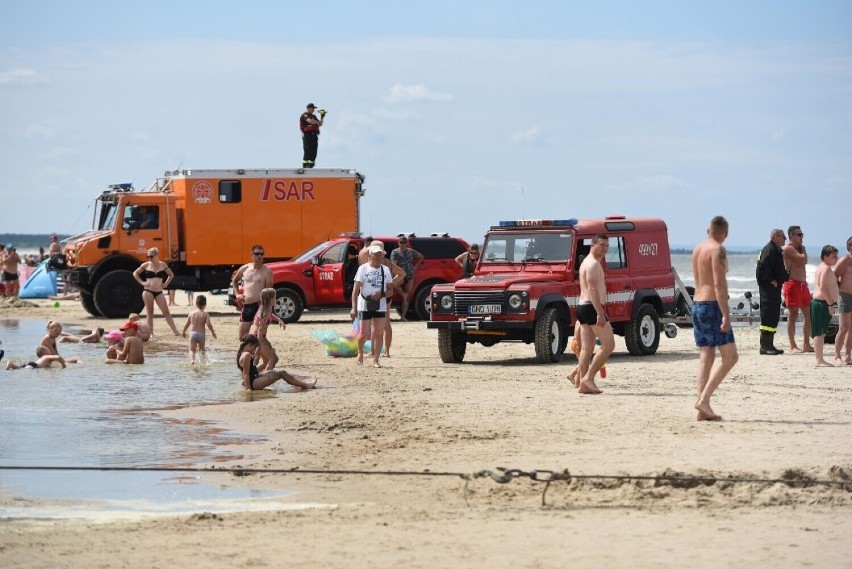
[427,216,676,363]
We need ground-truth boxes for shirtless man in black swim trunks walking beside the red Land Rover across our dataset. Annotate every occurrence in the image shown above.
[576,233,615,395]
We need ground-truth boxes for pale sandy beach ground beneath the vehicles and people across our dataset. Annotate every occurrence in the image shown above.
[0,294,852,569]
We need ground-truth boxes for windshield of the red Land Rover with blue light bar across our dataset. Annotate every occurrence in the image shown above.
[481,231,574,263]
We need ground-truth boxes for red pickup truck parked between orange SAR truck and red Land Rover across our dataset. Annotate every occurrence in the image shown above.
[260,233,468,323]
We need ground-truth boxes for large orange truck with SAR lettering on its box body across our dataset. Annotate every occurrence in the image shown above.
[56,168,364,318]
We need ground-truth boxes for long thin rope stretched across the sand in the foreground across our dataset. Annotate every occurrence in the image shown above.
[0,465,852,506]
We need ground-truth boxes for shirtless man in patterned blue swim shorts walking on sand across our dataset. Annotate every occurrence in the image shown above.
[692,215,739,421]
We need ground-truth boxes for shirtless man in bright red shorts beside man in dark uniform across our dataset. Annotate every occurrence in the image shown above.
[781,225,814,353]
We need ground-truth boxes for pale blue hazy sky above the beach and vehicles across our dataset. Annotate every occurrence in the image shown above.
[0,0,852,248]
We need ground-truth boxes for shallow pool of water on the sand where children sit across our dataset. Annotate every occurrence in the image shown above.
[0,318,292,517]
